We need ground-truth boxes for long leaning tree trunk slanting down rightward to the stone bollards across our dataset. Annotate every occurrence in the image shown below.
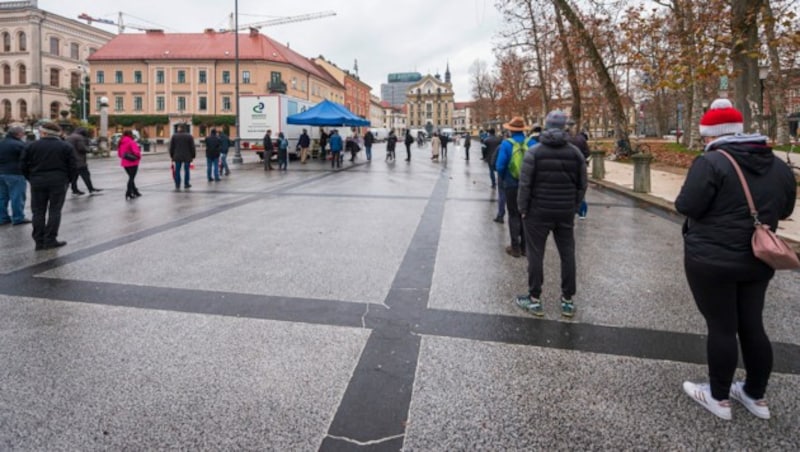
[553,0,629,143]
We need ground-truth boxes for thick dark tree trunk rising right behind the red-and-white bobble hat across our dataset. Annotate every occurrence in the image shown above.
[731,0,763,132]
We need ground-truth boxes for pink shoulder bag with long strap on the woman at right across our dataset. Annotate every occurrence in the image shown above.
[717,149,800,270]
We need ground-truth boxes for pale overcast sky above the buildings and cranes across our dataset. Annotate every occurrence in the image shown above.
[39,0,501,102]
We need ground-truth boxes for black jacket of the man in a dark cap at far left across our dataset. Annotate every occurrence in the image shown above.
[20,136,78,187]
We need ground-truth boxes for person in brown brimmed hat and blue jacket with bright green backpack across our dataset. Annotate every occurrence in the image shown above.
[495,116,531,257]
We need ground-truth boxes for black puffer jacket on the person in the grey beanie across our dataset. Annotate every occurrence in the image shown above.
[517,129,587,222]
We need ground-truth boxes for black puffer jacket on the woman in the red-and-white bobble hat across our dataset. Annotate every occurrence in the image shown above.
[675,134,797,270]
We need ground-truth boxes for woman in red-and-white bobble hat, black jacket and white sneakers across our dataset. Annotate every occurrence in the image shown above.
[675,99,797,420]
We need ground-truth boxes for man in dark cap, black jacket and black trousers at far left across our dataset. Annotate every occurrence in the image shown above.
[20,122,78,251]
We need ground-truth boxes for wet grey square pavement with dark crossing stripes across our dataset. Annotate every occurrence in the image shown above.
[0,144,800,451]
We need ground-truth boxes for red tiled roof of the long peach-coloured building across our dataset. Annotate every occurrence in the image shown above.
[89,32,339,85]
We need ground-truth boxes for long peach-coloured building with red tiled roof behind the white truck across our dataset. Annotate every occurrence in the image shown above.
[89,29,345,139]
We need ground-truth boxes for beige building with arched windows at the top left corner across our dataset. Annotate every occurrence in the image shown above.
[0,0,114,125]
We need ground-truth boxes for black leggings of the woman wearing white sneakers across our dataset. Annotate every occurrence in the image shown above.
[684,259,774,400]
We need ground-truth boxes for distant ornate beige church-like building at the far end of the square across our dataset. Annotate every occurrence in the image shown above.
[406,69,454,133]
